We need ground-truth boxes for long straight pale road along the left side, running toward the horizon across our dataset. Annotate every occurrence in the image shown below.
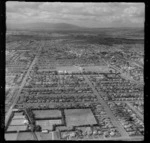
[5,47,41,125]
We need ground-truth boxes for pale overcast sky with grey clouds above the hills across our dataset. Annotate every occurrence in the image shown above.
[6,1,145,27]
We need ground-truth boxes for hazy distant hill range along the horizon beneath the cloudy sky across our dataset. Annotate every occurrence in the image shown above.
[7,22,144,32]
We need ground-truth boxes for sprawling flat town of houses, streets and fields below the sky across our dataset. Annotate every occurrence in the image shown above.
[5,1,144,141]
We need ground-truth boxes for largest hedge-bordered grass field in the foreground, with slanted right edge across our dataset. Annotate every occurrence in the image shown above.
[65,109,97,126]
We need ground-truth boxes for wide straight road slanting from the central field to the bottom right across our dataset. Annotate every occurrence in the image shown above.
[83,75,129,139]
